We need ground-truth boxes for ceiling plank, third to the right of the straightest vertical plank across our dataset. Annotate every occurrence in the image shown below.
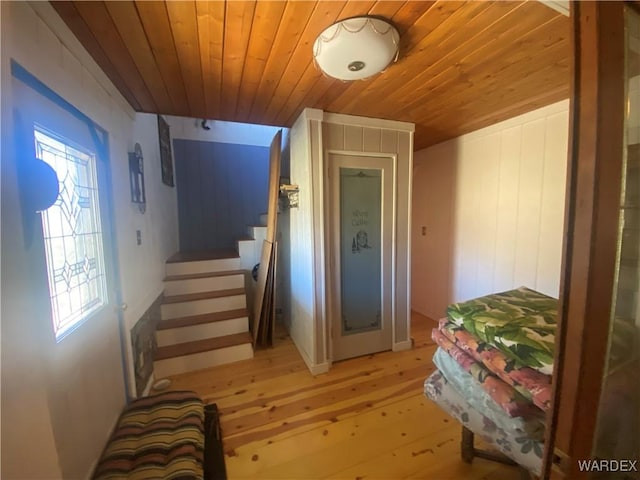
[249,1,316,123]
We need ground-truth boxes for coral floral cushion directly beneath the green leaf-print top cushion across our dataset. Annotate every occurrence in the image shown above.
[440,318,551,411]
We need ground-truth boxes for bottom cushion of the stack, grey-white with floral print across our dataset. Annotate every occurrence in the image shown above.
[424,370,544,475]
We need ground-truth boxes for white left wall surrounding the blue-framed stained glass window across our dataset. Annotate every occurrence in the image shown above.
[0,2,178,478]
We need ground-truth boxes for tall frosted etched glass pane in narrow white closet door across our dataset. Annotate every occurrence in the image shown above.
[340,168,382,335]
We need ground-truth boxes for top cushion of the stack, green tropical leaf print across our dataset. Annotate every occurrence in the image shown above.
[447,287,558,375]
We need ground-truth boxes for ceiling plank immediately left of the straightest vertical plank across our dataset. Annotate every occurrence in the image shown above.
[164,2,206,118]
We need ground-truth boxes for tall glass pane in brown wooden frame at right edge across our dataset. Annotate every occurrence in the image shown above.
[592,4,640,479]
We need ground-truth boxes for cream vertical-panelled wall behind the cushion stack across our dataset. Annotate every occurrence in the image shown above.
[412,100,569,318]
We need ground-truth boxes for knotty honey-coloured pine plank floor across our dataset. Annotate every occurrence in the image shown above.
[172,313,519,480]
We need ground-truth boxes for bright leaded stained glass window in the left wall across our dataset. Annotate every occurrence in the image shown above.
[34,128,107,340]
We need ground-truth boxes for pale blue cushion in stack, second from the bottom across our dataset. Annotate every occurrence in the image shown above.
[433,348,545,441]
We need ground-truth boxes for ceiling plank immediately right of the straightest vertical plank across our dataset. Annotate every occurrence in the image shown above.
[221,1,256,120]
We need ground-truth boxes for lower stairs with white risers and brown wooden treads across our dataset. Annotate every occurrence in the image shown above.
[154,250,253,378]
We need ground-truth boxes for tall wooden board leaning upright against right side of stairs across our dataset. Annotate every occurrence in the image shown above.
[251,130,282,347]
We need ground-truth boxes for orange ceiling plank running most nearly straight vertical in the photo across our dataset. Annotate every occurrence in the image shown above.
[195,2,225,118]
